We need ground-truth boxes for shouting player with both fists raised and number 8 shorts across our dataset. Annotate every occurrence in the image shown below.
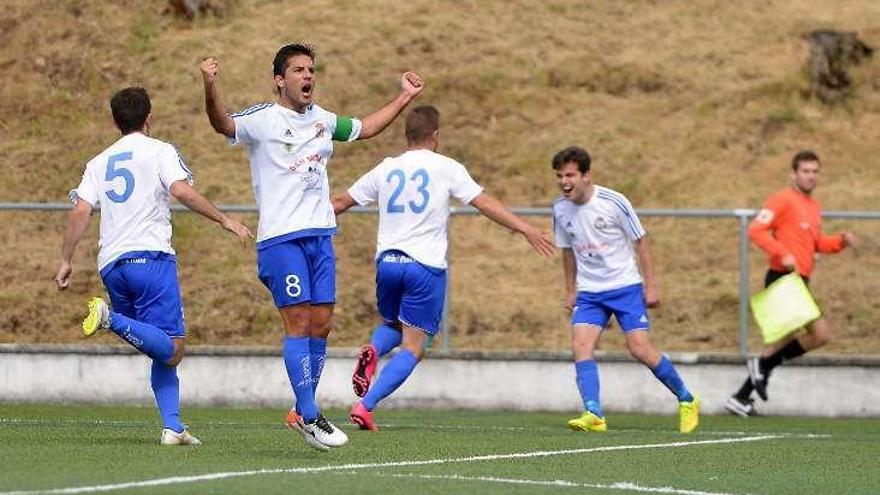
[200,43,423,450]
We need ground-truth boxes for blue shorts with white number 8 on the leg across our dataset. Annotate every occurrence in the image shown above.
[257,235,336,308]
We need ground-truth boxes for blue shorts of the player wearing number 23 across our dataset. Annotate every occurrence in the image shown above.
[376,250,446,335]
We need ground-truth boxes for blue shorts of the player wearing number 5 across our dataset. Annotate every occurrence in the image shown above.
[101,251,186,338]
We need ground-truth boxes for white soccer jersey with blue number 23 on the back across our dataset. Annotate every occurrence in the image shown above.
[348,150,483,269]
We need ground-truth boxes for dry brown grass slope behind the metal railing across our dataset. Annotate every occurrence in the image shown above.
[0,0,880,353]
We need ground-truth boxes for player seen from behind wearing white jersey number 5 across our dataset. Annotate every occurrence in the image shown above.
[55,88,252,445]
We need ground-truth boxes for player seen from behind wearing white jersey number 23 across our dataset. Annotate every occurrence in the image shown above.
[333,106,553,430]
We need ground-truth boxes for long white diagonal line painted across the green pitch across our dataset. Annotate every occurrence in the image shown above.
[0,435,783,495]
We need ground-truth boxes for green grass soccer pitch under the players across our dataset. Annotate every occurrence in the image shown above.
[0,404,880,495]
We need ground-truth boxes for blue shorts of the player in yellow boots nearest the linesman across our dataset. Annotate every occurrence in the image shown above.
[571,284,650,333]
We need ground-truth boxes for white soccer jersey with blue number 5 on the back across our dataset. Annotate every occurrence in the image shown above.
[70,132,192,276]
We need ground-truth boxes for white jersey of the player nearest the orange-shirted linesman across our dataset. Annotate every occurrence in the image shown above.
[553,186,645,292]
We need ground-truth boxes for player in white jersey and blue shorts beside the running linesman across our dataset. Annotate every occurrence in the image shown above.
[552,146,699,433]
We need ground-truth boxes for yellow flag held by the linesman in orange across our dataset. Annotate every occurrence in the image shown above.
[751,272,822,344]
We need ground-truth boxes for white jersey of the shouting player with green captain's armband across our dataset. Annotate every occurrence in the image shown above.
[230,103,361,248]
